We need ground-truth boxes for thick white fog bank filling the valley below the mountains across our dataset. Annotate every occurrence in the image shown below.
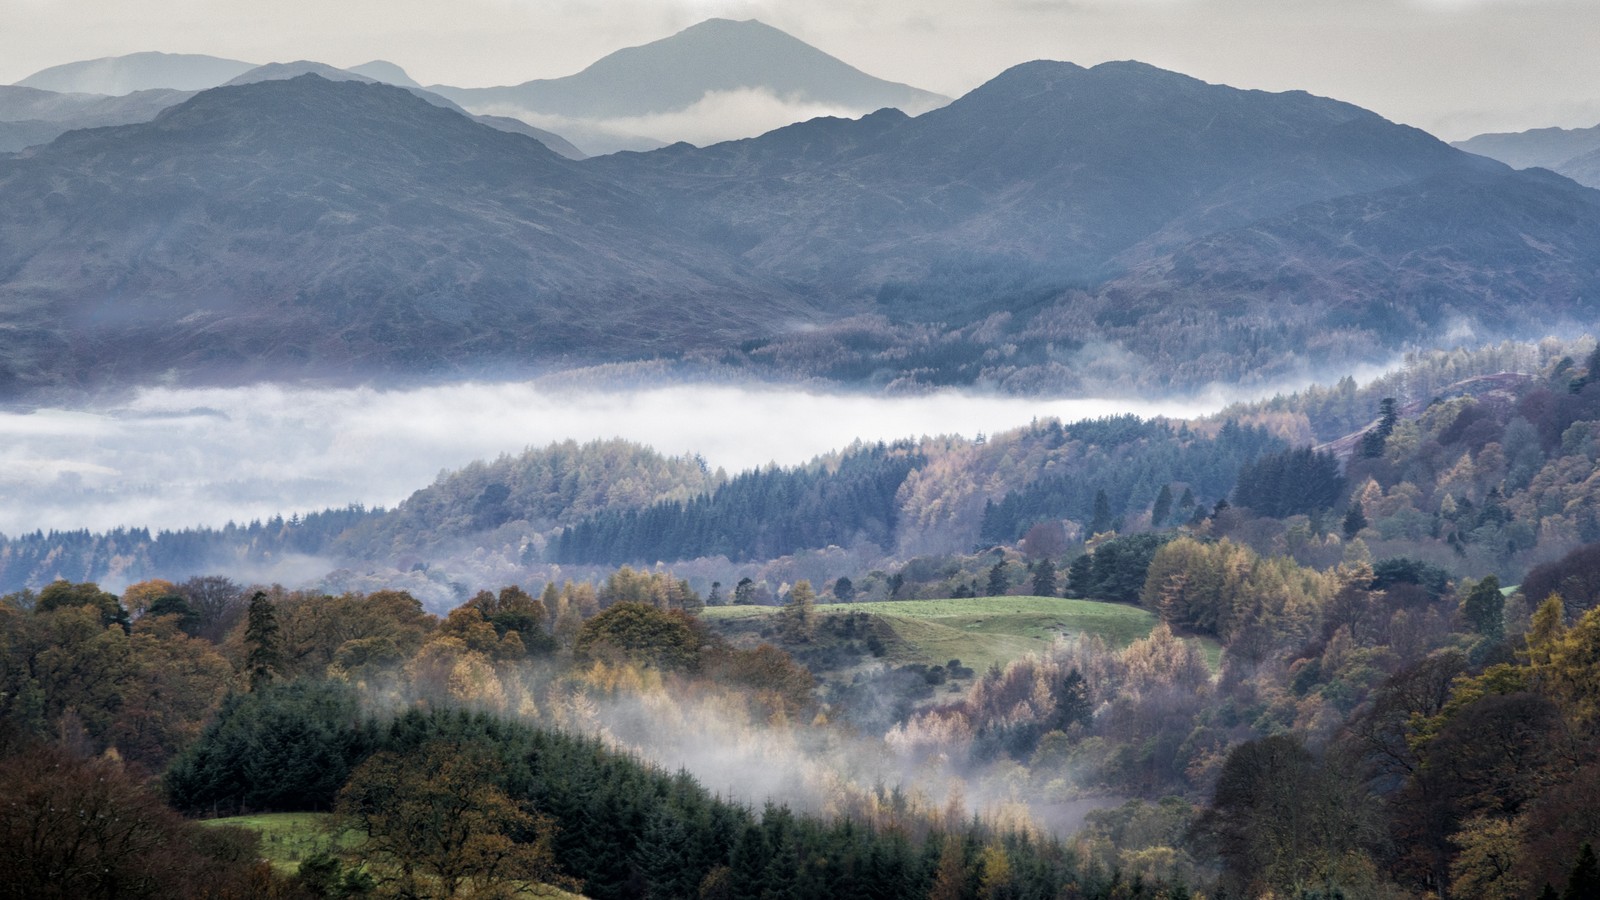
[0,376,1237,535]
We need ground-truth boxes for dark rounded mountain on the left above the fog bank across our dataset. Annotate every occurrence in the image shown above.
[0,75,805,389]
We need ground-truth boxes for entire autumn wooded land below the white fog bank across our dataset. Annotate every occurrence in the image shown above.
[15,341,1600,898]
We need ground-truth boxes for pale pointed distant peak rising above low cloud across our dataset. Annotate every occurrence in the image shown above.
[430,19,949,119]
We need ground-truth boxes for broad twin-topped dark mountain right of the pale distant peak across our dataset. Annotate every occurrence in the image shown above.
[594,62,1494,296]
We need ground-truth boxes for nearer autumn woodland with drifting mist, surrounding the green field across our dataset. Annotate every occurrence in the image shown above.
[15,483,1600,898]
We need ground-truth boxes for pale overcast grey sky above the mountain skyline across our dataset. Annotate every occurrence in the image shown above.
[0,0,1600,139]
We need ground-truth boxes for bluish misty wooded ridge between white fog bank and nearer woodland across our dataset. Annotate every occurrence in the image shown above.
[0,341,1600,612]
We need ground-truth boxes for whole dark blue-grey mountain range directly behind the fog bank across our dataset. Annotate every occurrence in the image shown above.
[0,48,1600,391]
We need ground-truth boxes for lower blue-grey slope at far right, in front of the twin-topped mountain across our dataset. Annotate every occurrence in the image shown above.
[1101,170,1600,346]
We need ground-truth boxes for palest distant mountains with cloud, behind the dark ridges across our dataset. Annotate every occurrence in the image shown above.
[9,19,950,159]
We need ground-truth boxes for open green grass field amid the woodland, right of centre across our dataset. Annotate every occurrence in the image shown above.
[702,597,1177,671]
